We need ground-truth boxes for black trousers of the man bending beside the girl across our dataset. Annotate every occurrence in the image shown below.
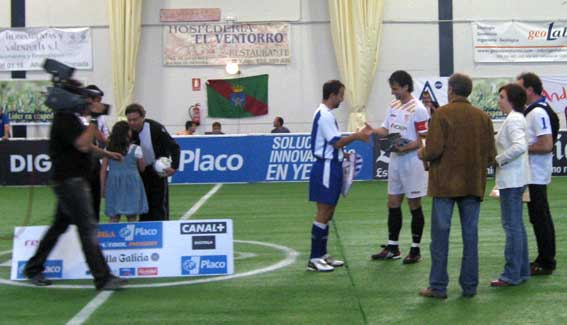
[140,166,169,221]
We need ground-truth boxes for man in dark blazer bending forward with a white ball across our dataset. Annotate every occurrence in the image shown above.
[126,103,180,221]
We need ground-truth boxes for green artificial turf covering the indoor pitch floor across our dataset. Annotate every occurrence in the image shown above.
[0,178,567,324]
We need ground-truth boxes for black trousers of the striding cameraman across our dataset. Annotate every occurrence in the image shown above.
[24,177,111,288]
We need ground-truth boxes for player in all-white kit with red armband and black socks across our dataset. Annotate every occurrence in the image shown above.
[371,70,429,264]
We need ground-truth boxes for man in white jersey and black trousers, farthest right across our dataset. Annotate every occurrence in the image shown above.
[517,73,556,275]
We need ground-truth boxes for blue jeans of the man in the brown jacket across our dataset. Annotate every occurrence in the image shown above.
[429,196,480,294]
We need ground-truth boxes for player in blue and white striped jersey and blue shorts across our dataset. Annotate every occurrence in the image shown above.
[307,80,372,272]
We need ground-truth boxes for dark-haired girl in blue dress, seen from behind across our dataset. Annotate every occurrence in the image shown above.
[100,121,148,223]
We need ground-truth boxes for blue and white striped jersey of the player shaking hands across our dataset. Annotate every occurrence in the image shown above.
[311,103,343,161]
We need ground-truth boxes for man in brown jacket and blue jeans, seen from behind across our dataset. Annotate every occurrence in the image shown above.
[418,73,495,299]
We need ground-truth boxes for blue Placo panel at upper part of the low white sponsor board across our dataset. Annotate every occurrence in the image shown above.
[97,222,163,249]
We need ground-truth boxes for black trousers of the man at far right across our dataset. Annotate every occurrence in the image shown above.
[528,184,556,270]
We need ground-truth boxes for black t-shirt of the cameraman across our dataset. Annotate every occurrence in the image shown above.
[49,112,91,181]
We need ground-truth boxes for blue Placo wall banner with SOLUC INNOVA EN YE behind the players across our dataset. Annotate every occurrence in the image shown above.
[172,134,374,183]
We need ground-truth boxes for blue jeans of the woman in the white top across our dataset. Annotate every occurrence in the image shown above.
[500,187,530,284]
